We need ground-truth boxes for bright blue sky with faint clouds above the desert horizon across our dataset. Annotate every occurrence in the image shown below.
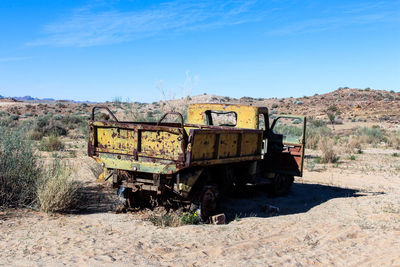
[0,0,400,102]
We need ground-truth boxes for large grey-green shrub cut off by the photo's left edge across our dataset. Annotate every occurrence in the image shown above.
[0,127,41,207]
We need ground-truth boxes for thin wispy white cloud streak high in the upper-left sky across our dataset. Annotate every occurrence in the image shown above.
[28,0,263,47]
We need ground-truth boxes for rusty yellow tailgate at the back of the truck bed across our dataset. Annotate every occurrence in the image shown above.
[88,122,186,174]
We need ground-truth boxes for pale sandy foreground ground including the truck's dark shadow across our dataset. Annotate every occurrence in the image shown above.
[0,149,400,266]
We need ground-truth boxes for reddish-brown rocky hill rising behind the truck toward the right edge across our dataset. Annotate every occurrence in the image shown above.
[158,87,400,123]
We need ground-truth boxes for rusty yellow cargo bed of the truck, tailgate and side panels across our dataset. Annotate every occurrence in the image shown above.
[88,121,263,174]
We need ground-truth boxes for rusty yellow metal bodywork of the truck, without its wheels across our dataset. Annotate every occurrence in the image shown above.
[88,104,305,205]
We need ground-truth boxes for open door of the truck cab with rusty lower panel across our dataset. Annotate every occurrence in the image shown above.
[265,115,306,176]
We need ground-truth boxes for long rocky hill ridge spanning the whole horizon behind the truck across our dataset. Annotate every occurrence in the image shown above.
[0,88,400,123]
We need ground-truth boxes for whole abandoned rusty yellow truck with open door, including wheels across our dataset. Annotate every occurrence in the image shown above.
[88,104,306,220]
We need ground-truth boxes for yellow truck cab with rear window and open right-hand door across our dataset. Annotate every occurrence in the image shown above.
[188,103,306,181]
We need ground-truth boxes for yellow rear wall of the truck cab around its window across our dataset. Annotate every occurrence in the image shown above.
[188,104,259,129]
